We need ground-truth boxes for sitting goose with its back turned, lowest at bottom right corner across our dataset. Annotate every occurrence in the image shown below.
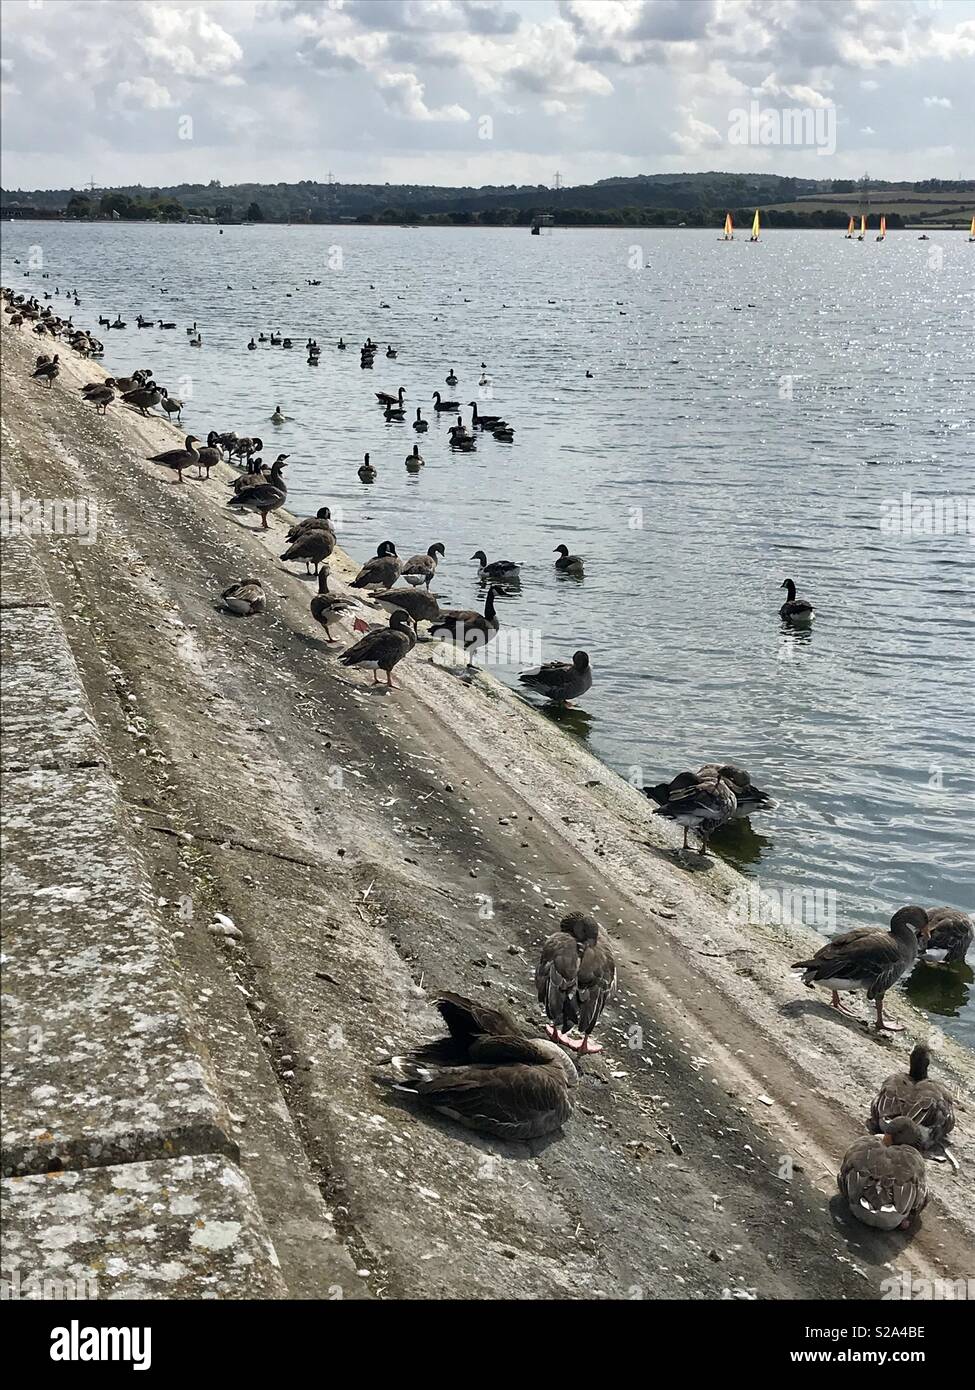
[836,1115,928,1230]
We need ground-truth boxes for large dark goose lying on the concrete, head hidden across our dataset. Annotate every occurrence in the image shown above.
[391,994,579,1140]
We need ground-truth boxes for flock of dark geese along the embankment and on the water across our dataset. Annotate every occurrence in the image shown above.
[3,273,974,1230]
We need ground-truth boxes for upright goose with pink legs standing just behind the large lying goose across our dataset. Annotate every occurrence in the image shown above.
[535,912,616,1052]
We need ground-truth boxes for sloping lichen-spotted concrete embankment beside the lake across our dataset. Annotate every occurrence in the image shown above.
[4,319,975,1298]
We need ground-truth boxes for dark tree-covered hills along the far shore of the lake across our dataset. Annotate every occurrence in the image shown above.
[0,171,975,227]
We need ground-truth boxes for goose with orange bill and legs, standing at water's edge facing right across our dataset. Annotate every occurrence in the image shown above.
[793,906,928,1033]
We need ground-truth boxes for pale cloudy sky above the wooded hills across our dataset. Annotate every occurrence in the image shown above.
[1,0,975,188]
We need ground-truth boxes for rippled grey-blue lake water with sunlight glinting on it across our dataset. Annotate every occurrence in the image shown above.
[3,222,975,1043]
